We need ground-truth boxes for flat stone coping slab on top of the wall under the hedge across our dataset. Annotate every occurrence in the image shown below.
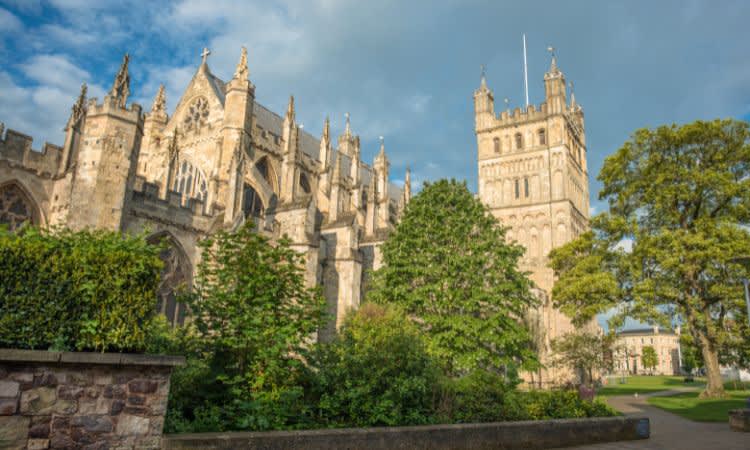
[0,348,185,367]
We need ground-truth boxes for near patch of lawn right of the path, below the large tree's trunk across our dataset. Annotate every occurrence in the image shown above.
[648,390,750,422]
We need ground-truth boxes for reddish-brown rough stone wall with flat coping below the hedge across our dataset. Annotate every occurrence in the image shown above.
[0,349,184,450]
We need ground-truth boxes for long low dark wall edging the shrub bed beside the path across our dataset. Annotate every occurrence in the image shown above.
[162,417,650,450]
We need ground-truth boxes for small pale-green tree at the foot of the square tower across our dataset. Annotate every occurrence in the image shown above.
[552,331,615,384]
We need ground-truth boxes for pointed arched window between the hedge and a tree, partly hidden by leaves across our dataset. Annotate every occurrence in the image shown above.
[147,232,191,326]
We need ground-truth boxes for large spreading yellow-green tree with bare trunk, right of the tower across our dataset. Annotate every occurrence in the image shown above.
[550,120,750,397]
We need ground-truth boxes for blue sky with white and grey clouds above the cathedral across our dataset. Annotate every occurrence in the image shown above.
[0,0,750,211]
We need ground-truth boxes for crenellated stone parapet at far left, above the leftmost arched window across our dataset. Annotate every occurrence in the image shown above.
[0,123,62,178]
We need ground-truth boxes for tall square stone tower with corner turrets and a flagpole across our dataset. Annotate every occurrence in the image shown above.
[474,55,595,383]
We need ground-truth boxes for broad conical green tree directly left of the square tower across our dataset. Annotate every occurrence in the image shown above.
[367,180,537,375]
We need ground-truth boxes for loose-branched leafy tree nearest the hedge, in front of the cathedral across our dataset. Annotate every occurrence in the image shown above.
[171,224,332,430]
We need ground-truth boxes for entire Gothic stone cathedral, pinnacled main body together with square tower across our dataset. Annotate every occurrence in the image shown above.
[0,48,589,384]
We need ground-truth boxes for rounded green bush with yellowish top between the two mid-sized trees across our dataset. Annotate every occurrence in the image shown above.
[315,304,439,427]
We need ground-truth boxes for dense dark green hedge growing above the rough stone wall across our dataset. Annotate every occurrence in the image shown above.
[0,228,162,351]
